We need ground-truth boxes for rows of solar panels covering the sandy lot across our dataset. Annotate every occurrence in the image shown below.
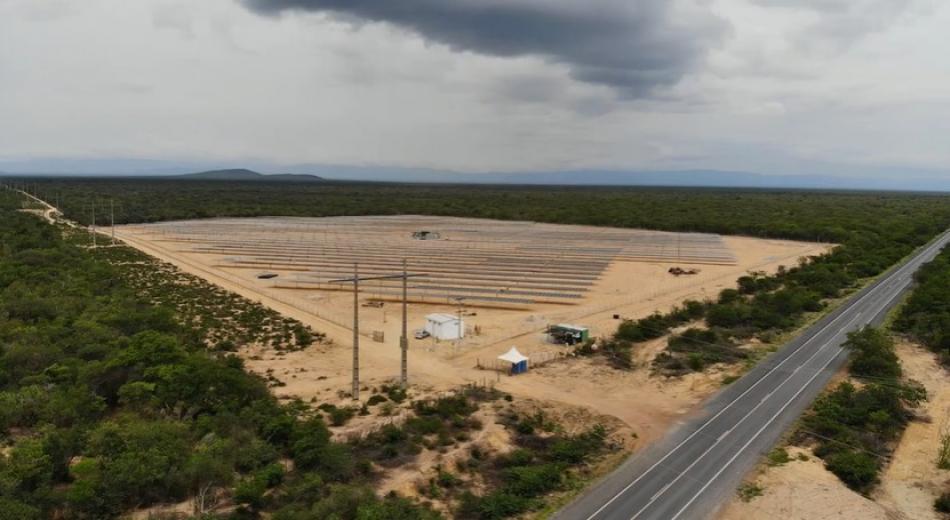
[124,216,736,306]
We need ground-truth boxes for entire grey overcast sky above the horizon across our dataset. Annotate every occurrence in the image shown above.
[0,0,950,177]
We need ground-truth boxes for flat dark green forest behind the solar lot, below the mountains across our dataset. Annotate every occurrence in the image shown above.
[7,178,950,243]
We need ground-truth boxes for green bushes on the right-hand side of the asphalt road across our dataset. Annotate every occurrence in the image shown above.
[797,250,950,502]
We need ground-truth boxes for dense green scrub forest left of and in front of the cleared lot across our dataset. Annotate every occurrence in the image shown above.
[0,192,607,520]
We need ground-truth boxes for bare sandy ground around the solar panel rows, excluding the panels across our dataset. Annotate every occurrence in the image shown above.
[109,218,830,441]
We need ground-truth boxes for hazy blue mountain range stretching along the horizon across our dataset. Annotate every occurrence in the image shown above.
[0,158,950,192]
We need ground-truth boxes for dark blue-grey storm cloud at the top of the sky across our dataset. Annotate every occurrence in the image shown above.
[243,0,725,97]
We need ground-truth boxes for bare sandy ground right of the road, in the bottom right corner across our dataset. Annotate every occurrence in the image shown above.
[718,342,950,520]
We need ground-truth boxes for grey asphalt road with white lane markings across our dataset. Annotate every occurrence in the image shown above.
[555,232,950,520]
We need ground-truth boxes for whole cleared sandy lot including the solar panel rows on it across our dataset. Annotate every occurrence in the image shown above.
[117,216,828,438]
